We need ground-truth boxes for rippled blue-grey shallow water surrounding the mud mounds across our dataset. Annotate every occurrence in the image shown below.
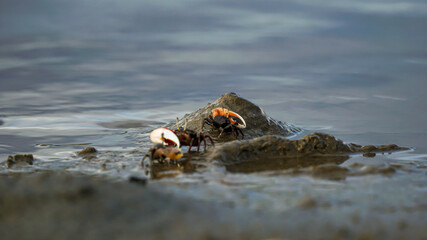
[0,0,427,226]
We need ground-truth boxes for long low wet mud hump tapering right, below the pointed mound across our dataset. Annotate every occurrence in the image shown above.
[208,133,407,172]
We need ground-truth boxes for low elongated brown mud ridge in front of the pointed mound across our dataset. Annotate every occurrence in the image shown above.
[208,133,407,167]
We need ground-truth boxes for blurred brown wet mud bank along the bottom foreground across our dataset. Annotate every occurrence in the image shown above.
[0,173,426,239]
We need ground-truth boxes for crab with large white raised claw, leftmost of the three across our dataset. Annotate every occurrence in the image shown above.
[142,128,183,163]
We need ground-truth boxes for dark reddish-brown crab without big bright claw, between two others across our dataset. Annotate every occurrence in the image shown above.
[173,118,215,152]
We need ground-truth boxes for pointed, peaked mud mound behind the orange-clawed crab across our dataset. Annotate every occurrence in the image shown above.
[166,93,301,141]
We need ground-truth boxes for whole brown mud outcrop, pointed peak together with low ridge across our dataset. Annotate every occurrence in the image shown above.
[161,93,407,176]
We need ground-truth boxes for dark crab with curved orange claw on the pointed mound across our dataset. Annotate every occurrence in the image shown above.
[202,108,246,138]
